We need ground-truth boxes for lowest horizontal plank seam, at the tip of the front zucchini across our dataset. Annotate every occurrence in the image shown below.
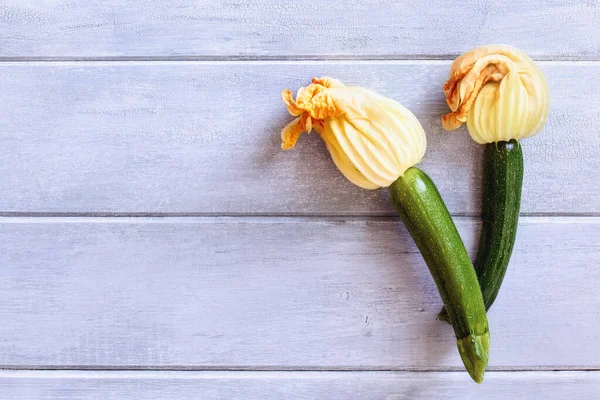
[0,365,600,373]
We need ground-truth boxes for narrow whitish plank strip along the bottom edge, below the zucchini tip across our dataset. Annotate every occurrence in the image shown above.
[0,371,600,400]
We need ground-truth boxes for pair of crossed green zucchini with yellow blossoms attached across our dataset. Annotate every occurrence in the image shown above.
[281,46,548,383]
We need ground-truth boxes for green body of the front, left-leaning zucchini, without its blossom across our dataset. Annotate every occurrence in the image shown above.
[390,167,490,383]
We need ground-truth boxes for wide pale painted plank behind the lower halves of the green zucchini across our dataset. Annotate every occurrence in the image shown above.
[0,217,600,370]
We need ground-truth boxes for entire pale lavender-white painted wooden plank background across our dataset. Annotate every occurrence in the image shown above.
[0,0,600,400]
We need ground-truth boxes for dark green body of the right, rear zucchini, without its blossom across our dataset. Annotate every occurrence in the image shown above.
[438,139,523,322]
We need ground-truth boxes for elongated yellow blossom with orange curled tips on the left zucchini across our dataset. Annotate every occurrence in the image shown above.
[281,77,426,189]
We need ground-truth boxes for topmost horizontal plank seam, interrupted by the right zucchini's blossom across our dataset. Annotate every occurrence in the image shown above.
[0,54,600,65]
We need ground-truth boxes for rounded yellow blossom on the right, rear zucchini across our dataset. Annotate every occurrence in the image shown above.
[442,45,549,144]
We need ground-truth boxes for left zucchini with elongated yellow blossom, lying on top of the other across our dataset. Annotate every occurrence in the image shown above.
[281,78,489,382]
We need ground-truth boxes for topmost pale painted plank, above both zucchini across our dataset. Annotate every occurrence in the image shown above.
[0,0,600,60]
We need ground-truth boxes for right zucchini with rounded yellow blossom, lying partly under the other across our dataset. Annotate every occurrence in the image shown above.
[439,45,550,320]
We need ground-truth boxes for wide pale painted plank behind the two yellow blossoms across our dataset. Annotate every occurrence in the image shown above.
[0,61,600,215]
